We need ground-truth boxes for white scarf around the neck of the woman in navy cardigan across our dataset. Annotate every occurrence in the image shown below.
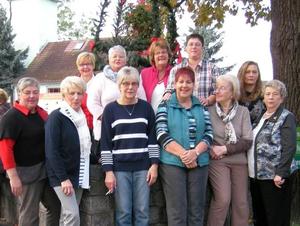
[60,101,92,158]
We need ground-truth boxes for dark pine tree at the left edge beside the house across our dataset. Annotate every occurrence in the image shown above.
[0,4,28,94]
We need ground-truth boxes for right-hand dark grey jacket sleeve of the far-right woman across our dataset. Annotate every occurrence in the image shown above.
[276,113,297,178]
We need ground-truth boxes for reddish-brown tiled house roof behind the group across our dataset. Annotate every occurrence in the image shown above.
[21,40,90,83]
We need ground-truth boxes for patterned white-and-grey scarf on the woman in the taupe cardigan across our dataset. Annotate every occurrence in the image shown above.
[216,101,238,144]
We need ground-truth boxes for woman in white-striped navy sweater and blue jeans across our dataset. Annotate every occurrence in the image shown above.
[101,67,159,226]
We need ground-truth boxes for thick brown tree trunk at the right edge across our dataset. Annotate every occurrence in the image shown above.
[271,0,300,125]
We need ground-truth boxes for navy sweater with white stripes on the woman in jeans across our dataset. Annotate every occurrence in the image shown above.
[101,99,159,171]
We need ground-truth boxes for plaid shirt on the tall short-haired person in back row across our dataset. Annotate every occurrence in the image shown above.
[166,58,219,98]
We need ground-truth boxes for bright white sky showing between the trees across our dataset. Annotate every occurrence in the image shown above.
[74,0,273,80]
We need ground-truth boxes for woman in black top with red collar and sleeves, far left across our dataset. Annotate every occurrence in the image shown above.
[0,77,60,226]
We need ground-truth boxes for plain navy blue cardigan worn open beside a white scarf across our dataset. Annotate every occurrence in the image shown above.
[45,109,80,188]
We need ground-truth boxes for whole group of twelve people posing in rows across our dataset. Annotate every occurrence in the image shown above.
[0,34,296,226]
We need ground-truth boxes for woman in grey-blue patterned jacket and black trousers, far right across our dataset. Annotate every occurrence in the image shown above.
[248,80,296,226]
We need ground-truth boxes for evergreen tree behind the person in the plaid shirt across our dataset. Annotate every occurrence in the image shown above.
[190,26,235,74]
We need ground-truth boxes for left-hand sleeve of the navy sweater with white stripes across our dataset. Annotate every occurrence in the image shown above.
[100,105,113,172]
